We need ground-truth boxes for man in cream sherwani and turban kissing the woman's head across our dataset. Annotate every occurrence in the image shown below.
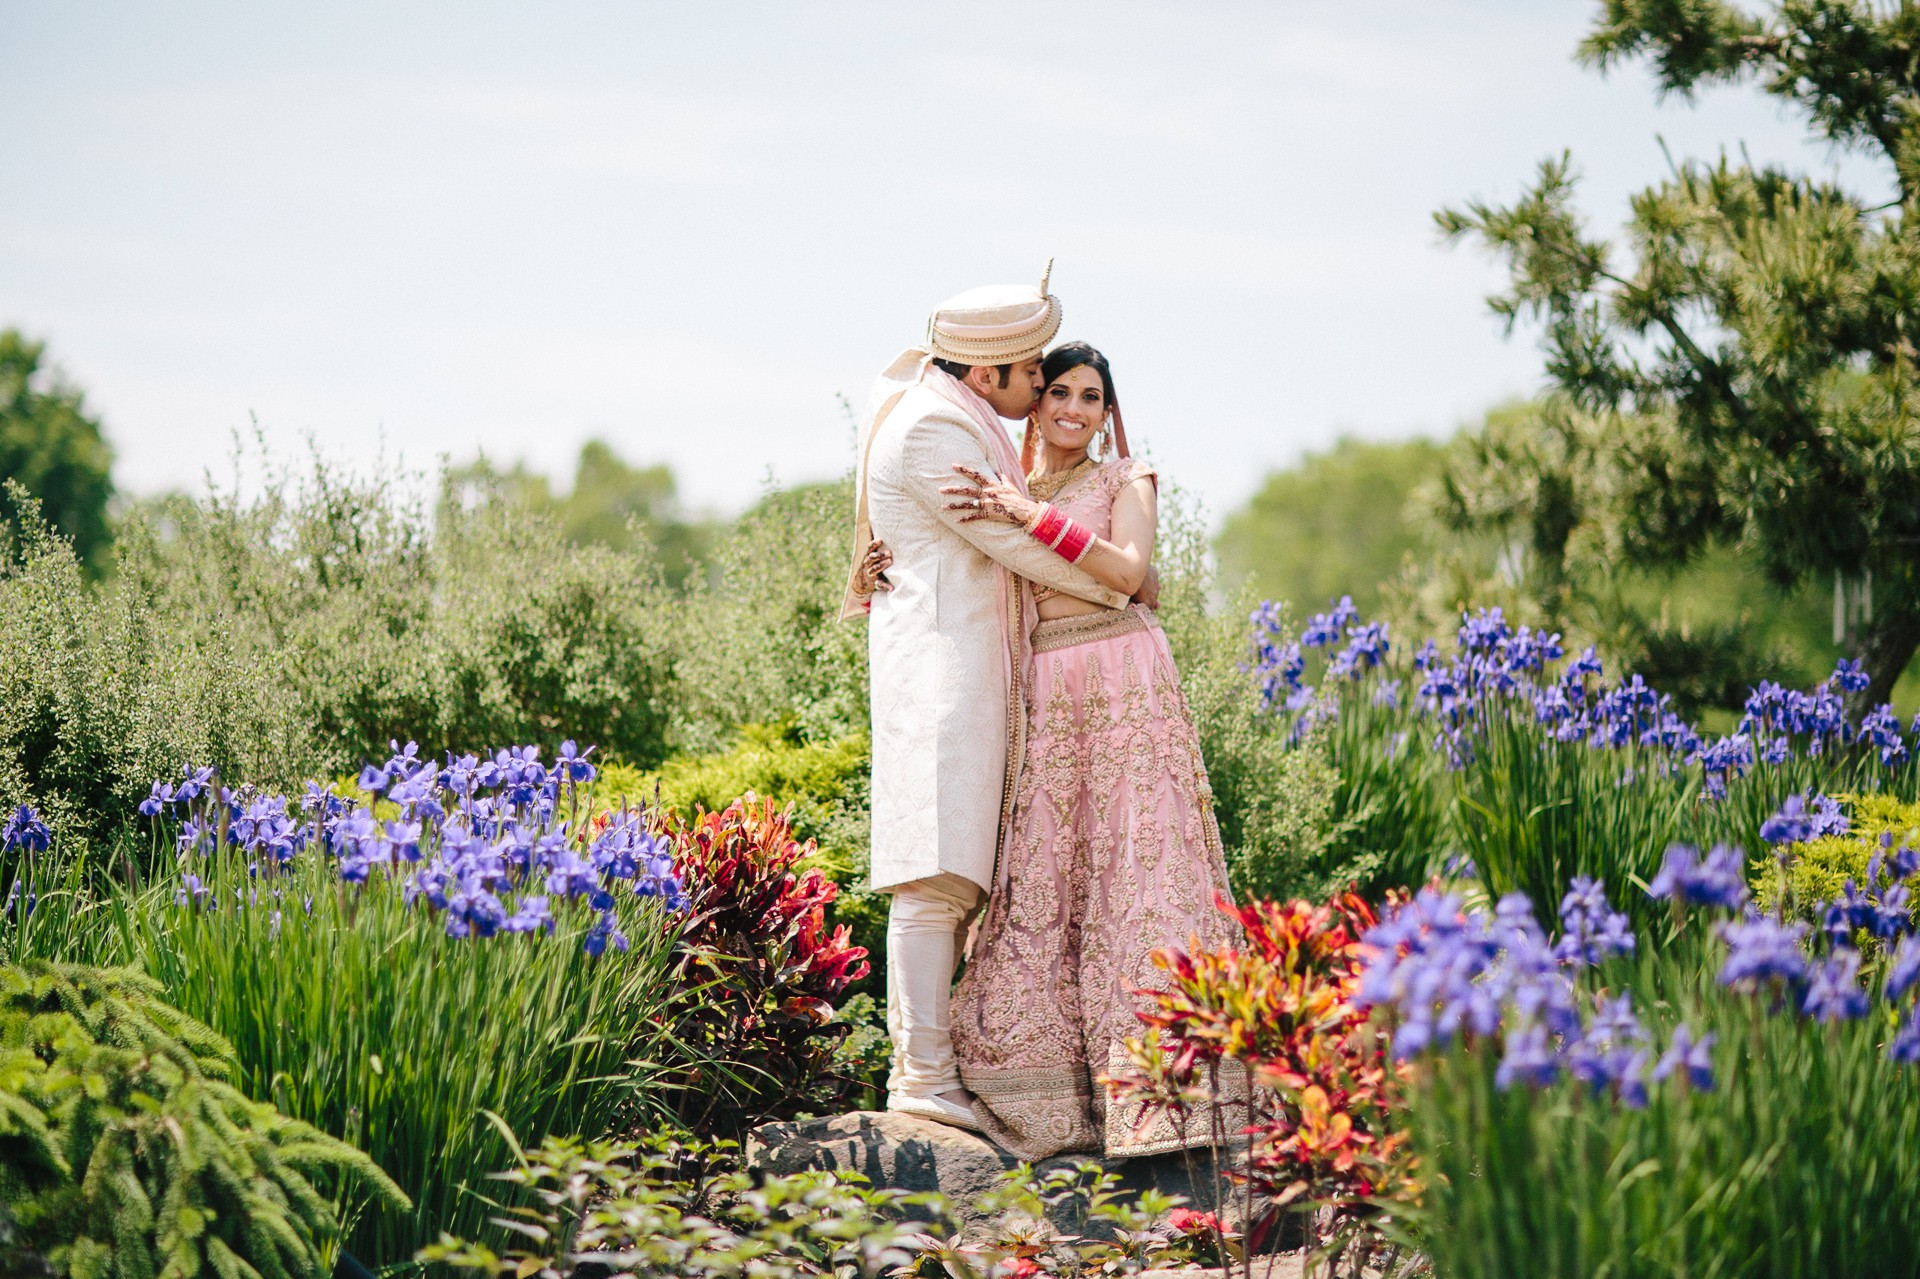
[841,268,1127,1127]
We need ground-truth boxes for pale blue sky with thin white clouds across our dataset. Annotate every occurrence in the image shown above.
[0,0,1880,517]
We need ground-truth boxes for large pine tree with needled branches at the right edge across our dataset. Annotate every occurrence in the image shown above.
[1436,0,1920,703]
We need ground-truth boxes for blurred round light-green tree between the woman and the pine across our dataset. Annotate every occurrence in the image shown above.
[1215,440,1442,615]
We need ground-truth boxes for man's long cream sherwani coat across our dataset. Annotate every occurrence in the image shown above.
[847,351,1127,891]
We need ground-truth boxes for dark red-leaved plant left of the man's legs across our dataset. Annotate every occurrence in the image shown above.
[666,791,868,1135]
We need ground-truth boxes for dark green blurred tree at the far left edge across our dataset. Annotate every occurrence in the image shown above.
[0,328,113,563]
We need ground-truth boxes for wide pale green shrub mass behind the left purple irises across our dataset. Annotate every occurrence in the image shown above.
[0,451,674,856]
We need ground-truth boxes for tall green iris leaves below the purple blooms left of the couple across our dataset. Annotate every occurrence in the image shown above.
[111,837,676,1262]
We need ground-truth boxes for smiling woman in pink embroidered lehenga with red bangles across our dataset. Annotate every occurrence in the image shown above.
[870,342,1236,1160]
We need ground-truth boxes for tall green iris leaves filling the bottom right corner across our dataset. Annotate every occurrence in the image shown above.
[1396,906,1920,1279]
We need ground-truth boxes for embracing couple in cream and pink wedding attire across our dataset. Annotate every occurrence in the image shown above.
[843,266,1235,1160]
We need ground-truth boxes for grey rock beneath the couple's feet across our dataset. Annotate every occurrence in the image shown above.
[745,1110,1236,1227]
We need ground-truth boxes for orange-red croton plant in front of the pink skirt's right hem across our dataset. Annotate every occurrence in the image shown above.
[1108,893,1411,1246]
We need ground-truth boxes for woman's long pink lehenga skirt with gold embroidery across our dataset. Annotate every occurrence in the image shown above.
[952,605,1238,1160]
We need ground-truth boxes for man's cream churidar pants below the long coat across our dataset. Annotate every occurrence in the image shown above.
[887,874,981,1097]
